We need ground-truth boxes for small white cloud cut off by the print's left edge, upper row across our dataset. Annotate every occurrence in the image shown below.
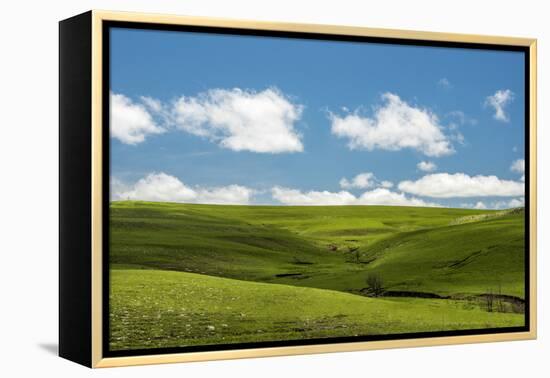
[110,93,165,145]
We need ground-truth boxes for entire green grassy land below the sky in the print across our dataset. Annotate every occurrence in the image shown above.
[109,201,525,350]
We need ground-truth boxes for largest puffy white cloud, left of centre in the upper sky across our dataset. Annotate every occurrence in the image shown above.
[172,88,304,153]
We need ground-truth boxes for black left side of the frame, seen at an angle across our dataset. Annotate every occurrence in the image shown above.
[59,12,93,367]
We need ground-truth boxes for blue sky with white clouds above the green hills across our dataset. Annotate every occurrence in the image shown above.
[110,28,525,208]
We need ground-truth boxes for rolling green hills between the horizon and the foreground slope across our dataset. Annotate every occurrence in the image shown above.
[110,201,524,298]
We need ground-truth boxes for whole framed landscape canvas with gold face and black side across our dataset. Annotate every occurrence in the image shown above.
[59,11,536,367]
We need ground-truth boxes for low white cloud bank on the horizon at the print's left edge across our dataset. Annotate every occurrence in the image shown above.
[111,172,254,205]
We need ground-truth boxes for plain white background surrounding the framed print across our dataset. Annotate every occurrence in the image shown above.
[0,0,550,378]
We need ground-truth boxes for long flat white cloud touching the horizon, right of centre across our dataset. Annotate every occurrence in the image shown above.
[272,187,438,206]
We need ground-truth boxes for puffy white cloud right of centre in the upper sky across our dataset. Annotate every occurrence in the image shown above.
[329,93,454,157]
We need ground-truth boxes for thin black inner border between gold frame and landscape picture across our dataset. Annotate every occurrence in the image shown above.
[102,21,531,357]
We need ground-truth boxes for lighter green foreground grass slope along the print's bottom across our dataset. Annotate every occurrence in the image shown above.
[110,269,523,350]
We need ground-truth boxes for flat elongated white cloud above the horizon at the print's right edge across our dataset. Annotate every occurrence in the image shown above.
[398,173,525,198]
